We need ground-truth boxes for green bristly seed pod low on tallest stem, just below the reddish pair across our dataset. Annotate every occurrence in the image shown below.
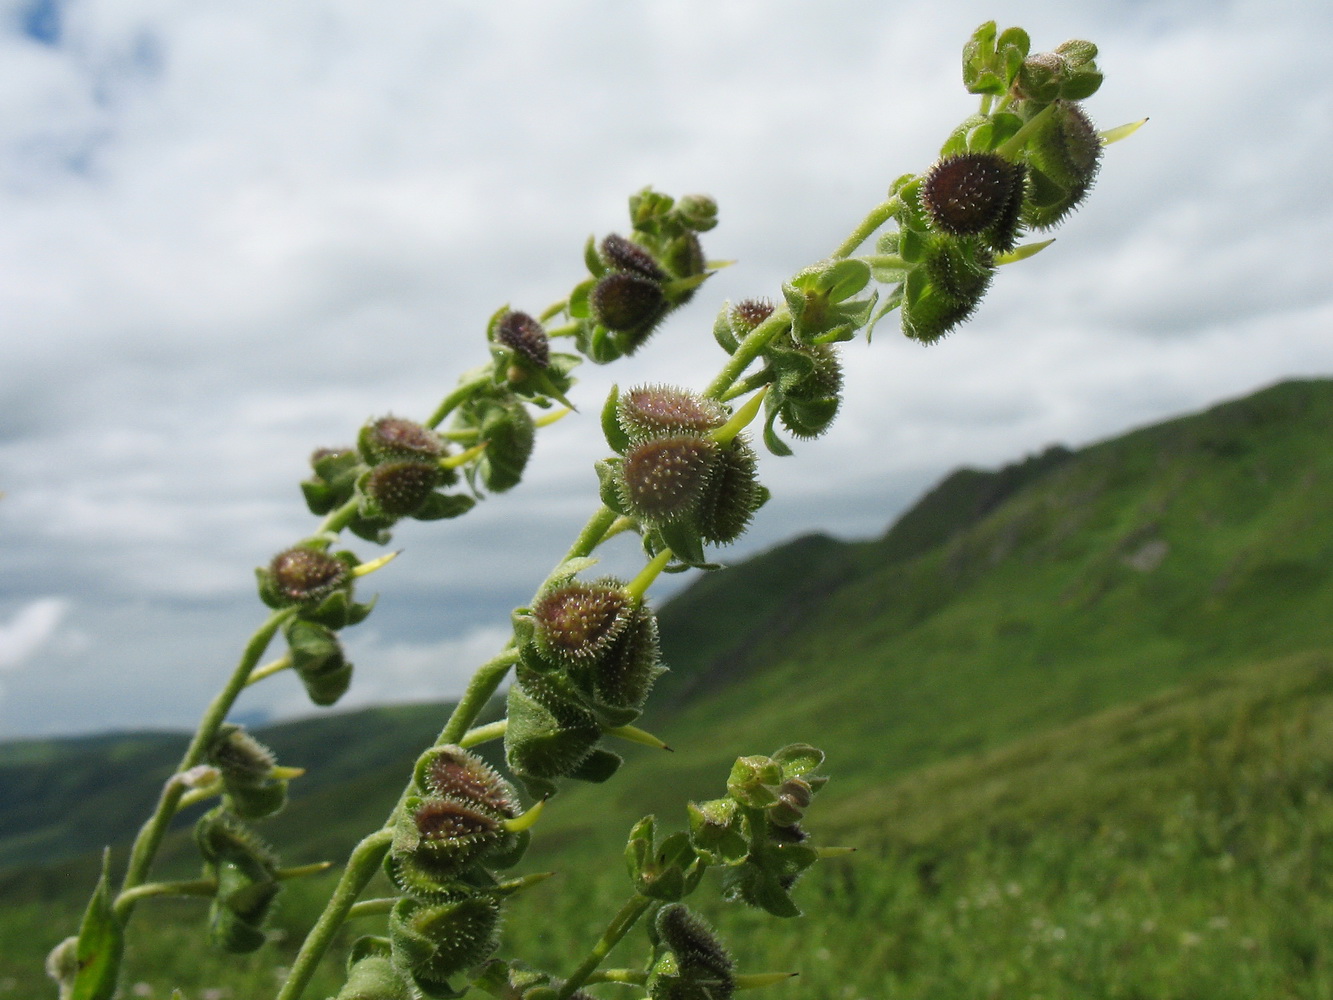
[389,896,500,992]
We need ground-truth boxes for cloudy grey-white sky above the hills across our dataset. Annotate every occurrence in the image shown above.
[0,0,1333,740]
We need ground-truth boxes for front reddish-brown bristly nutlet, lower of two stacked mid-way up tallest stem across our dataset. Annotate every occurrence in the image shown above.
[621,433,720,524]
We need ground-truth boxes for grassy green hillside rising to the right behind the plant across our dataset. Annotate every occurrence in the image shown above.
[0,380,1333,1000]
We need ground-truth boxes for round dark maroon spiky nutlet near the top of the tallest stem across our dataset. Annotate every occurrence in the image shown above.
[921,152,1022,236]
